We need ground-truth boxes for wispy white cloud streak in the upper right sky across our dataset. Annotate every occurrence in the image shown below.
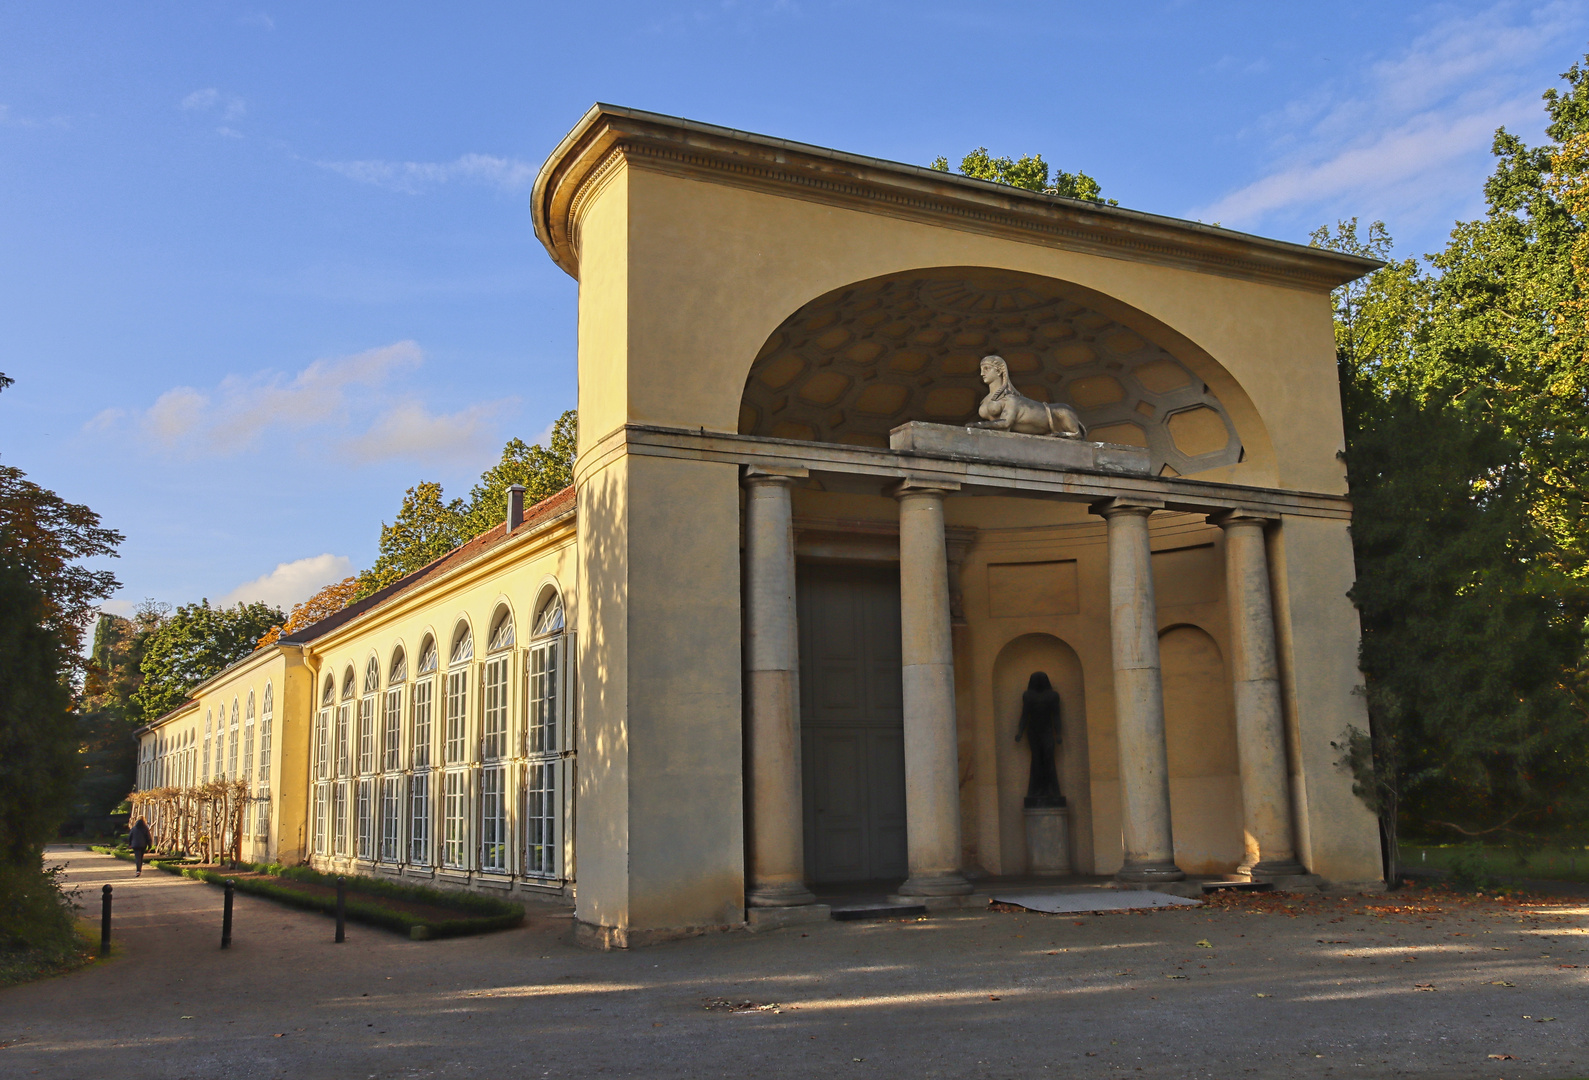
[1189,2,1589,229]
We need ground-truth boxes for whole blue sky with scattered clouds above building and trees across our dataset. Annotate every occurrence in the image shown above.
[0,0,1589,611]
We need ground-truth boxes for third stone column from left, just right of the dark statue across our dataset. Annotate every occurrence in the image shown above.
[1093,499,1185,883]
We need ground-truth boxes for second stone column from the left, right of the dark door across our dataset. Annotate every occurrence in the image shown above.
[895,480,971,896]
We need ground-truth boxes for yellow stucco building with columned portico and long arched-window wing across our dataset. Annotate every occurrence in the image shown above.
[140,106,1381,945]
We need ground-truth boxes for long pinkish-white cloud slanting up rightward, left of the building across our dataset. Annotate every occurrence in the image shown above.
[131,341,424,454]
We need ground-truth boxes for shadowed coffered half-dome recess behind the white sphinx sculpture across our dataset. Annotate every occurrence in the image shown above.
[739,267,1268,476]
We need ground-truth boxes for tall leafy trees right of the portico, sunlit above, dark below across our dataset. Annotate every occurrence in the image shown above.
[1314,52,1589,857]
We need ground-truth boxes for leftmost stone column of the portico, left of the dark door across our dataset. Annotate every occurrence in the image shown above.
[745,467,815,907]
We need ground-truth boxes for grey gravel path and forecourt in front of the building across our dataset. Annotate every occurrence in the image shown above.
[0,850,1589,1080]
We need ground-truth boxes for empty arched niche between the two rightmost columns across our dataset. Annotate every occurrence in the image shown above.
[1158,626,1244,874]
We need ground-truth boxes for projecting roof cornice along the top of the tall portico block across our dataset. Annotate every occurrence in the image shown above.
[531,105,1381,292]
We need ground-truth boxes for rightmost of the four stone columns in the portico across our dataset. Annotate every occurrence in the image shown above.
[1209,510,1308,875]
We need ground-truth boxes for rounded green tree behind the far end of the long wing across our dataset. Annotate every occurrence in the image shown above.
[132,600,286,723]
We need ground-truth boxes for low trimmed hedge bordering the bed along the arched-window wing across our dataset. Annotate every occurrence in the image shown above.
[94,847,524,942]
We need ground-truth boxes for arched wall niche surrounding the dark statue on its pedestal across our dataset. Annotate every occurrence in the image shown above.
[988,634,1093,874]
